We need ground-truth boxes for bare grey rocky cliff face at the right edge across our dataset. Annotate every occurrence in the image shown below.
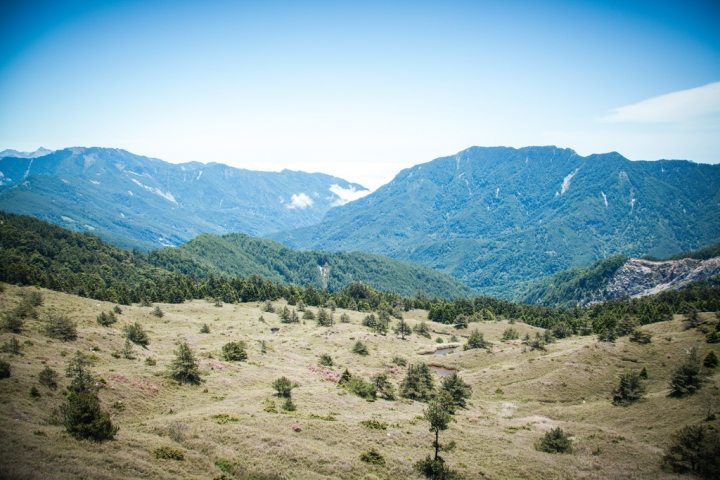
[596,257,720,301]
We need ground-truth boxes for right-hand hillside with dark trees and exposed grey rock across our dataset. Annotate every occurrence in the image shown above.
[516,244,720,307]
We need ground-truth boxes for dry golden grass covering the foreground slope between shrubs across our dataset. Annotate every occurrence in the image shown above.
[0,286,720,479]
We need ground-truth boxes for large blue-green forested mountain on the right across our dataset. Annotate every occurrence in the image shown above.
[269,147,720,298]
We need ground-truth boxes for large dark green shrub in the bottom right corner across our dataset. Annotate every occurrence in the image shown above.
[663,425,720,478]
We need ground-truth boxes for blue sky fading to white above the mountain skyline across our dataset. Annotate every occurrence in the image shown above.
[0,0,720,188]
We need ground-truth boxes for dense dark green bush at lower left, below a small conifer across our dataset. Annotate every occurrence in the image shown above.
[60,392,118,442]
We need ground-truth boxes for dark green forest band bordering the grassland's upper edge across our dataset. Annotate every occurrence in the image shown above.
[0,213,720,333]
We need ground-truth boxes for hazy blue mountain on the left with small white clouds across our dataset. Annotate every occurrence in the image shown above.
[0,148,364,249]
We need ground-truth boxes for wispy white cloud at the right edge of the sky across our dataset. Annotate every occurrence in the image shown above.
[599,82,720,123]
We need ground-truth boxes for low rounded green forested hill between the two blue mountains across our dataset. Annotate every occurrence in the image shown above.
[148,234,475,299]
